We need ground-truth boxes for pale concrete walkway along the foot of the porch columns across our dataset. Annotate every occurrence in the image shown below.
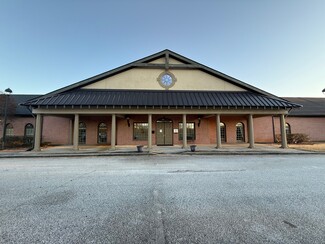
[0,143,314,158]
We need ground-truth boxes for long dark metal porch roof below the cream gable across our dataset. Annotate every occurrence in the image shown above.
[24,89,300,108]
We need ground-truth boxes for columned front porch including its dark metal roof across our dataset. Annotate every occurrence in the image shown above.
[25,89,299,151]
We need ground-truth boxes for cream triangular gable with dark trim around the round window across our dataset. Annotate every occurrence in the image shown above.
[39,50,276,97]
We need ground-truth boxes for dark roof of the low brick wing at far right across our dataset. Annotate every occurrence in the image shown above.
[284,97,325,117]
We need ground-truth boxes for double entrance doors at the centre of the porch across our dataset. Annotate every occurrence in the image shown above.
[156,120,173,146]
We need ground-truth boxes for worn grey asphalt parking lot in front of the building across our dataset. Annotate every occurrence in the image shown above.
[0,155,325,243]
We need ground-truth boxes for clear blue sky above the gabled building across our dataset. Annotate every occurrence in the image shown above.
[0,0,325,97]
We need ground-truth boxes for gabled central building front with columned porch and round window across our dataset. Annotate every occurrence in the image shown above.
[16,50,301,150]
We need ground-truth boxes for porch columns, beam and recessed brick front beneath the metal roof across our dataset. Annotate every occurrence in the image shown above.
[30,109,287,151]
